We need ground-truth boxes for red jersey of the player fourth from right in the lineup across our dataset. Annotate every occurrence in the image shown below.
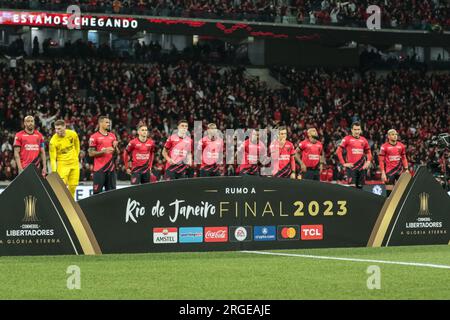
[269,140,295,177]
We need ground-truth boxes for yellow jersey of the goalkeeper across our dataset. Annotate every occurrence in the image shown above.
[49,129,80,172]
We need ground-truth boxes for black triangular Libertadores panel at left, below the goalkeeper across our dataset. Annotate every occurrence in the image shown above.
[0,165,83,255]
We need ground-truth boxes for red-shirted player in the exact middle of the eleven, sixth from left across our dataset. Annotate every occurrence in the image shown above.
[197,123,223,177]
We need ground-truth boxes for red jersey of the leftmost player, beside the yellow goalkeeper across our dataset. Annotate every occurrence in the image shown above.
[14,130,45,169]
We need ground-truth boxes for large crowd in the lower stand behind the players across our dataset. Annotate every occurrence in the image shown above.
[0,51,450,184]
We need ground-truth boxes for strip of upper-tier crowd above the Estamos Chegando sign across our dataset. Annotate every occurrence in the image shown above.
[0,0,450,30]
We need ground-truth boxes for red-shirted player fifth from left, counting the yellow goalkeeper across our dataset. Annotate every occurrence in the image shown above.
[162,120,193,180]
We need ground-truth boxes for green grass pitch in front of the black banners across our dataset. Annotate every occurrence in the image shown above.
[0,246,450,300]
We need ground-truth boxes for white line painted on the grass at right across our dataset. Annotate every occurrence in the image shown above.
[240,251,450,269]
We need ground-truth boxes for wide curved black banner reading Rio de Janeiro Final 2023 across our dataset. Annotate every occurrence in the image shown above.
[79,177,385,253]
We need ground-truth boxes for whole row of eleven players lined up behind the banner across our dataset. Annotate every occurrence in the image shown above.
[14,116,408,195]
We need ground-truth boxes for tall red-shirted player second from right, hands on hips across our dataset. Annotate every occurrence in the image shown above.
[336,122,372,189]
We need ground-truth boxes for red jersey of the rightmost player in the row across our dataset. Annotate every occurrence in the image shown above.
[379,142,408,175]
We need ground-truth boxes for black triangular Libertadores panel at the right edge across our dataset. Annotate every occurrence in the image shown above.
[383,166,450,246]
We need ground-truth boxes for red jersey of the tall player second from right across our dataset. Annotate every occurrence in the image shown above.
[337,136,372,170]
